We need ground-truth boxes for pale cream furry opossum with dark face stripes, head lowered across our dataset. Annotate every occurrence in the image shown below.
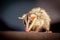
[18,7,51,32]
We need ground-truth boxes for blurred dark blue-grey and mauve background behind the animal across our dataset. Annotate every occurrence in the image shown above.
[0,0,60,33]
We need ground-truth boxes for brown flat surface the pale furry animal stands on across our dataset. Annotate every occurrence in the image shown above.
[1,31,60,40]
